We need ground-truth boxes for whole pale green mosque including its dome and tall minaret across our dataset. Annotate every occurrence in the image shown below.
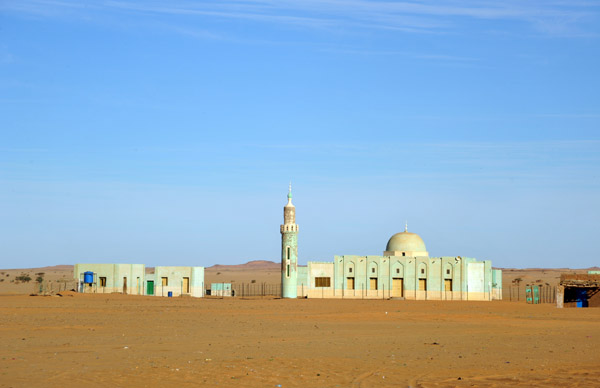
[280,185,502,301]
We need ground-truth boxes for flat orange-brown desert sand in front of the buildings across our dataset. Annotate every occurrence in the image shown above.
[0,294,600,387]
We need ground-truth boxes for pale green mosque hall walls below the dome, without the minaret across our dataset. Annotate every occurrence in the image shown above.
[298,250,502,300]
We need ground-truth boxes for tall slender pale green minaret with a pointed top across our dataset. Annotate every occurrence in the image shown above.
[280,182,298,298]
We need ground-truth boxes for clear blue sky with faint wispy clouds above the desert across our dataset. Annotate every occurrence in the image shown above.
[0,0,600,268]
